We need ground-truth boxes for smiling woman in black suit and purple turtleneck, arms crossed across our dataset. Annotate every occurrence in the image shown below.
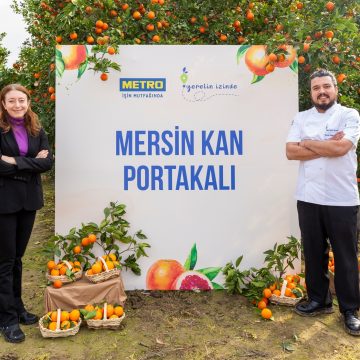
[0,84,52,343]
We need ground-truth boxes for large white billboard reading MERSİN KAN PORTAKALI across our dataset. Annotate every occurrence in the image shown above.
[55,45,298,289]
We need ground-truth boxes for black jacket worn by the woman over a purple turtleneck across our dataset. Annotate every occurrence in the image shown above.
[0,129,53,214]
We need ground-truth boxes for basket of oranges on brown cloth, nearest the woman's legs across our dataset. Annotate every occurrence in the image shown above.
[46,260,82,284]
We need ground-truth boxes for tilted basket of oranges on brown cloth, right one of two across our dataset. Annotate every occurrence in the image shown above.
[85,254,121,283]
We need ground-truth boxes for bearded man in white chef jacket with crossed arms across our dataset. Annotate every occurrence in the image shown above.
[286,70,360,335]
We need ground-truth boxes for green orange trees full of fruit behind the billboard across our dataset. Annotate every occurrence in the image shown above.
[0,0,360,148]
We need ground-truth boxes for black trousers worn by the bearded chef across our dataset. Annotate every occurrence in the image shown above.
[297,201,360,312]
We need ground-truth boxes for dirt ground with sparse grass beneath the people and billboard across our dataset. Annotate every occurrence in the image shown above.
[0,181,360,360]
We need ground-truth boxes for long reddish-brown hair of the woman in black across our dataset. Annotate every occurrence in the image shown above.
[0,84,41,136]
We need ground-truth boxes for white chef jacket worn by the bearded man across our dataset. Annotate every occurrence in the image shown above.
[286,103,360,206]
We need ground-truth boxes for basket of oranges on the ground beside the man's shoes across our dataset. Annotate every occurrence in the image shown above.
[264,275,304,306]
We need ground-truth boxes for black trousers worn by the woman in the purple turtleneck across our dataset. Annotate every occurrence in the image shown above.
[0,210,36,326]
